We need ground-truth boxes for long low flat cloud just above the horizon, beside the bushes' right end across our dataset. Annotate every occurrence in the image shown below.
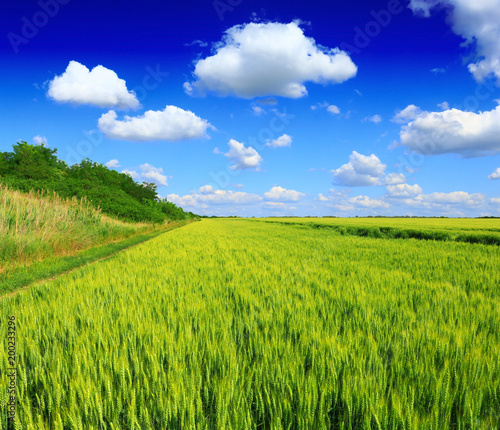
[167,189,262,207]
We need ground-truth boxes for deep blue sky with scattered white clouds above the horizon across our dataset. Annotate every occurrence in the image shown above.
[0,0,500,216]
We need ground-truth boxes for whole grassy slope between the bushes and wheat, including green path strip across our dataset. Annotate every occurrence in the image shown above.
[0,185,188,294]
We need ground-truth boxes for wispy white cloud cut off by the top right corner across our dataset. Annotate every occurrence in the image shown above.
[410,0,500,81]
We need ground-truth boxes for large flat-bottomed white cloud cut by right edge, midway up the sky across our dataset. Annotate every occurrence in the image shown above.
[395,105,500,157]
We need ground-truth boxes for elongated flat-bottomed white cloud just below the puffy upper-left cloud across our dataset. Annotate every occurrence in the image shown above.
[98,105,212,142]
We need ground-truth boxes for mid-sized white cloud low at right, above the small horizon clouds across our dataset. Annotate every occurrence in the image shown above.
[331,151,387,187]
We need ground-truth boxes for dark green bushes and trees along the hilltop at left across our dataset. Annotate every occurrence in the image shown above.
[0,142,195,223]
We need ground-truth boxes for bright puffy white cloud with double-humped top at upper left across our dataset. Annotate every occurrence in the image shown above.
[47,61,140,109]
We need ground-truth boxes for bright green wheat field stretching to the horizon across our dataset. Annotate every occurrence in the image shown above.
[0,219,500,429]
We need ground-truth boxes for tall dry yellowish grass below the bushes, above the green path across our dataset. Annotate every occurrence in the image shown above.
[0,185,152,269]
